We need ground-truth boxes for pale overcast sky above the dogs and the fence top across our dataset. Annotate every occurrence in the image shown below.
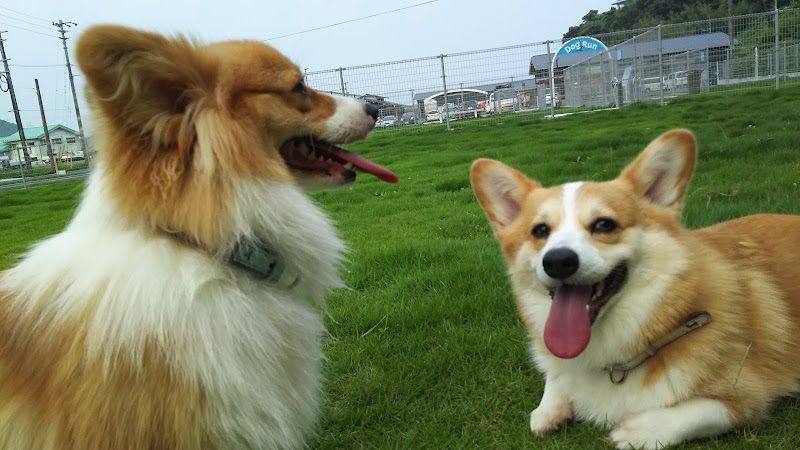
[0,0,612,135]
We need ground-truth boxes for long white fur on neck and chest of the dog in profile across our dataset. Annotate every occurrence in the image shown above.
[6,174,344,448]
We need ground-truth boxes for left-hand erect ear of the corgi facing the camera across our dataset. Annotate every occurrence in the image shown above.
[471,159,541,234]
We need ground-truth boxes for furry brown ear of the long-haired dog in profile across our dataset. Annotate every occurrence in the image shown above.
[75,25,213,141]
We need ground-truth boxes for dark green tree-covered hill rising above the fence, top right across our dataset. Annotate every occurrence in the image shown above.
[564,0,800,39]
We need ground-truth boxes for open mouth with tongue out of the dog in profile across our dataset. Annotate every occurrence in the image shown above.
[280,136,397,183]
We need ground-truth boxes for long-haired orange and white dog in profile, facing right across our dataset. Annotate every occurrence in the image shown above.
[0,25,397,450]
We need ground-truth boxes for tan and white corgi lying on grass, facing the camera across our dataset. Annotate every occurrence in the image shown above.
[471,130,800,449]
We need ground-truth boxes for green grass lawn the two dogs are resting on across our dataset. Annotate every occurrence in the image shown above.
[0,87,800,449]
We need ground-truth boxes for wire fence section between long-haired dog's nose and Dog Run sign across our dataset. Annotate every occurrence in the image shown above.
[305,43,550,128]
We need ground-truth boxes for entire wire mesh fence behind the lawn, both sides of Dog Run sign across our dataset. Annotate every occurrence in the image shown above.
[305,9,800,130]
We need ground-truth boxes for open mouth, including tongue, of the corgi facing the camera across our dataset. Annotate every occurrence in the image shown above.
[544,263,628,359]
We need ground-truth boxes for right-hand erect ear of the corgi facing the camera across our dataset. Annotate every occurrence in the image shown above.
[620,130,697,214]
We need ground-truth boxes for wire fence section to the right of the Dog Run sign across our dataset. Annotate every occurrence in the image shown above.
[563,10,800,107]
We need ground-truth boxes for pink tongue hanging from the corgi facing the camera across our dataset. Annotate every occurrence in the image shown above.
[544,285,592,359]
